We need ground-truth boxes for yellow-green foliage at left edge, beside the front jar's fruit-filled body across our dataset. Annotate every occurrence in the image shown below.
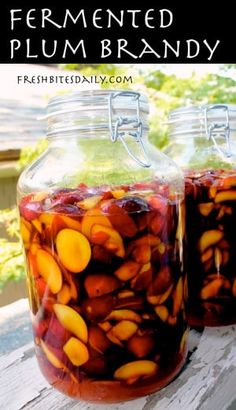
[0,207,25,289]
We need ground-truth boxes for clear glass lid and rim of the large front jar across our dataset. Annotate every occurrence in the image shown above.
[46,90,149,136]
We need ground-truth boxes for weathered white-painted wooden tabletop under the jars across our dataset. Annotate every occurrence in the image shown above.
[0,299,236,410]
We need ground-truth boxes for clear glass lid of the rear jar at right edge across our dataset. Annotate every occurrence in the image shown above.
[168,104,236,137]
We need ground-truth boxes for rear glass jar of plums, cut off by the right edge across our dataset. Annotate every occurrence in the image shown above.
[165,104,236,326]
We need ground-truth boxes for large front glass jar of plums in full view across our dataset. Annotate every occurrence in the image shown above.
[18,91,187,402]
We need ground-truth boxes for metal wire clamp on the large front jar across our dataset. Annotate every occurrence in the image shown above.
[108,91,151,168]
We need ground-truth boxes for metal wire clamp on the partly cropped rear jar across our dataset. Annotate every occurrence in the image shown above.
[204,104,232,157]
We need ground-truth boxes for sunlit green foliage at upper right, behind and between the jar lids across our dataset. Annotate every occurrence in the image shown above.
[139,64,236,148]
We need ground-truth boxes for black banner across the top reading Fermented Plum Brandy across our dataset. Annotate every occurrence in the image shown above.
[0,0,233,64]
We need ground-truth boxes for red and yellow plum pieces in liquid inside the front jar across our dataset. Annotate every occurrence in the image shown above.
[19,184,187,401]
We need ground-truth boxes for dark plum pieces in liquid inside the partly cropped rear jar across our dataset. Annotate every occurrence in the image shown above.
[186,170,236,326]
